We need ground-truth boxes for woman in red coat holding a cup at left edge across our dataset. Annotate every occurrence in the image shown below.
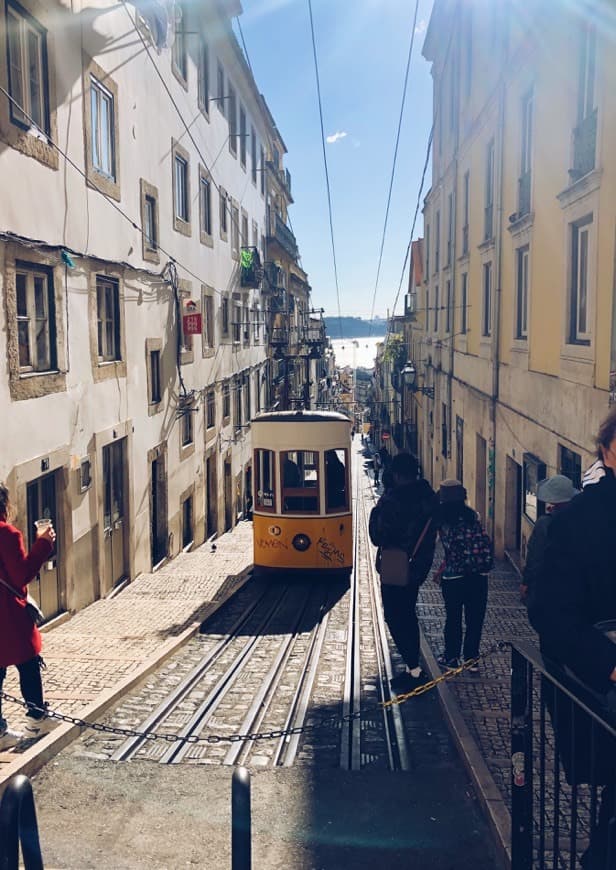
[0,483,56,749]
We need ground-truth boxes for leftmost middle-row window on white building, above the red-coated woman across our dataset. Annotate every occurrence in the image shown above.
[15,262,57,372]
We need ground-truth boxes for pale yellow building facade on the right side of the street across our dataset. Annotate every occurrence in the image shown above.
[410,0,616,562]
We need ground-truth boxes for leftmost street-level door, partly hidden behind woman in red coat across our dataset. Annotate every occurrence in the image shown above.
[26,472,61,619]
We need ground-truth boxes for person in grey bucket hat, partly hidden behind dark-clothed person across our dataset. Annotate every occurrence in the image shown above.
[520,474,579,612]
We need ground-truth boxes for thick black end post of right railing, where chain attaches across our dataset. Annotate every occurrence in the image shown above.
[511,647,533,870]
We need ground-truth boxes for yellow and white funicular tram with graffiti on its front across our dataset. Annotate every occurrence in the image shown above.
[251,411,353,575]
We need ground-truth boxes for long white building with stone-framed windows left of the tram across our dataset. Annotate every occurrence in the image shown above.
[0,0,312,616]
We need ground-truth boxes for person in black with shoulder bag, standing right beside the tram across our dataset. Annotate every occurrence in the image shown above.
[369,453,436,693]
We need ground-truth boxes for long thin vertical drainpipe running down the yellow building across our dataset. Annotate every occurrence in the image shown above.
[487,80,505,541]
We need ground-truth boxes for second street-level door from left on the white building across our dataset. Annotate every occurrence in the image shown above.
[101,438,128,595]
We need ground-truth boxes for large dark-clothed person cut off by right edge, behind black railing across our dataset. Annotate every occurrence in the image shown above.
[533,408,616,870]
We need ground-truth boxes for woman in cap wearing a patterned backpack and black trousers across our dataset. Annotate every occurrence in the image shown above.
[435,480,492,673]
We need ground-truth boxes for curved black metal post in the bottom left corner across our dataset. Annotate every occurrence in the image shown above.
[0,774,43,870]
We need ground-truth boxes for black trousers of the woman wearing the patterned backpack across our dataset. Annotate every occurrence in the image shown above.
[441,574,488,661]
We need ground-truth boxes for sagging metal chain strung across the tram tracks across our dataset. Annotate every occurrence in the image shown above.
[0,641,510,743]
